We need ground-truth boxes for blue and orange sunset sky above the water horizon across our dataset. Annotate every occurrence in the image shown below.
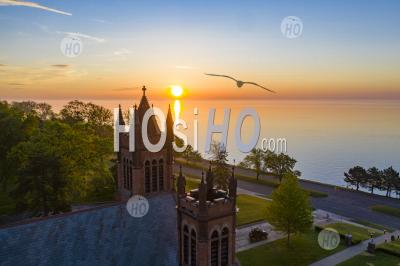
[0,0,400,100]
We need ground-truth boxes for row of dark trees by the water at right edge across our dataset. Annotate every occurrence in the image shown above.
[344,166,400,197]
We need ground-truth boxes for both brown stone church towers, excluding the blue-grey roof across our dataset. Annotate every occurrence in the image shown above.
[118,87,237,266]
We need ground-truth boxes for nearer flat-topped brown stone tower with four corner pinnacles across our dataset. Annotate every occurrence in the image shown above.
[177,165,237,266]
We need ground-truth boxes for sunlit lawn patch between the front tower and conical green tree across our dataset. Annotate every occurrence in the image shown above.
[236,195,268,226]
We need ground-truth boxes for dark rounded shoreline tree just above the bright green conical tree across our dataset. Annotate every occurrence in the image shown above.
[264,152,301,183]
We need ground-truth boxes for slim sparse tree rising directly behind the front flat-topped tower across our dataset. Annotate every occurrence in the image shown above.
[211,142,231,190]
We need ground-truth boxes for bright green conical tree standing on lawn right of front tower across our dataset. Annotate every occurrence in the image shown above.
[267,173,313,246]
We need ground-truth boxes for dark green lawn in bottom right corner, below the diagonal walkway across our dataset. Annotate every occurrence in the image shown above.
[338,251,400,266]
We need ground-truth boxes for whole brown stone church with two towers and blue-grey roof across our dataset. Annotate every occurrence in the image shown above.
[0,88,237,266]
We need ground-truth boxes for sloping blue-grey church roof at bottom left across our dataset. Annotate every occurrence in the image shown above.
[0,193,179,266]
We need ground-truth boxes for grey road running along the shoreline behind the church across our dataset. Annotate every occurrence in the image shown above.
[175,164,400,229]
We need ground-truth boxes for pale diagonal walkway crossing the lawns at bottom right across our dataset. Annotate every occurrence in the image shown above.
[310,230,400,266]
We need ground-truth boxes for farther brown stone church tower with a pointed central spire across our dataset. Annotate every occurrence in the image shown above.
[117,86,174,200]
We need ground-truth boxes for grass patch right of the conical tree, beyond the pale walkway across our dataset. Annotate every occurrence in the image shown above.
[318,223,382,244]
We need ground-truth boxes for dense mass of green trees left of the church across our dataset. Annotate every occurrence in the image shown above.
[0,101,116,216]
